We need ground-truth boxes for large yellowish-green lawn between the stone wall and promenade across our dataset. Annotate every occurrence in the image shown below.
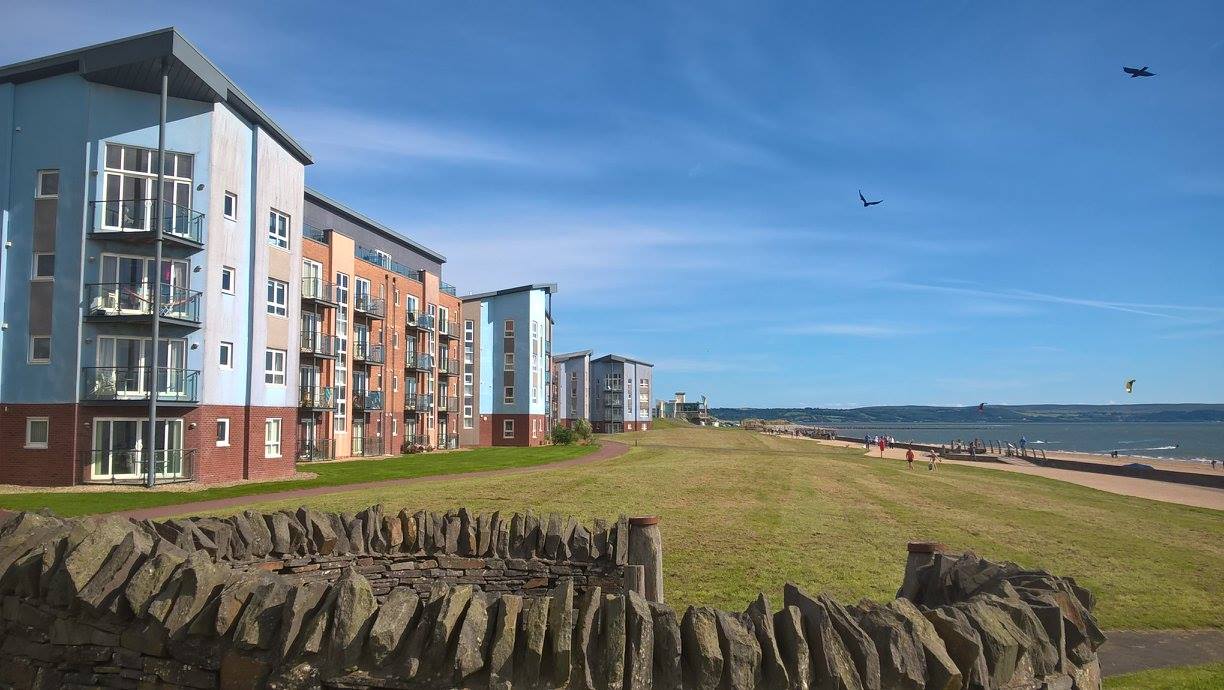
[205,427,1224,629]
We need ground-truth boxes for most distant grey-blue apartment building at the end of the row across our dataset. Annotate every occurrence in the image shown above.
[590,355,654,433]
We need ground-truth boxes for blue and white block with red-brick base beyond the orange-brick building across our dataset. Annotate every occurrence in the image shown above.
[459,284,557,445]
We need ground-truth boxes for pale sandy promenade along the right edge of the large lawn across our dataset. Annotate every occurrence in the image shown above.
[813,439,1224,510]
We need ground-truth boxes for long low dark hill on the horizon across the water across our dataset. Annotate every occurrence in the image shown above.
[710,403,1224,426]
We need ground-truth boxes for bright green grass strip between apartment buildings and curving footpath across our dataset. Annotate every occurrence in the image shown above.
[0,445,596,516]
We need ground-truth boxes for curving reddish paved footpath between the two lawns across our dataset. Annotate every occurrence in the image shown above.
[114,440,629,520]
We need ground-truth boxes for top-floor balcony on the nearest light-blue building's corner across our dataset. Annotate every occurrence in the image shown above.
[89,199,204,250]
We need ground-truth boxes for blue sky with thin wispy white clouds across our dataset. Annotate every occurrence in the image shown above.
[0,0,1224,407]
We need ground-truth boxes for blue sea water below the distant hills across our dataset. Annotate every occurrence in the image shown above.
[837,422,1224,462]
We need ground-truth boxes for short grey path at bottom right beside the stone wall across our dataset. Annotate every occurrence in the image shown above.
[1098,629,1224,677]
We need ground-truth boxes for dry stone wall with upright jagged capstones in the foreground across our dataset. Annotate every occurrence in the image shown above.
[0,506,1104,690]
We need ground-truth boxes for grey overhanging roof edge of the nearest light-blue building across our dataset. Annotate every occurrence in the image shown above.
[0,26,315,165]
